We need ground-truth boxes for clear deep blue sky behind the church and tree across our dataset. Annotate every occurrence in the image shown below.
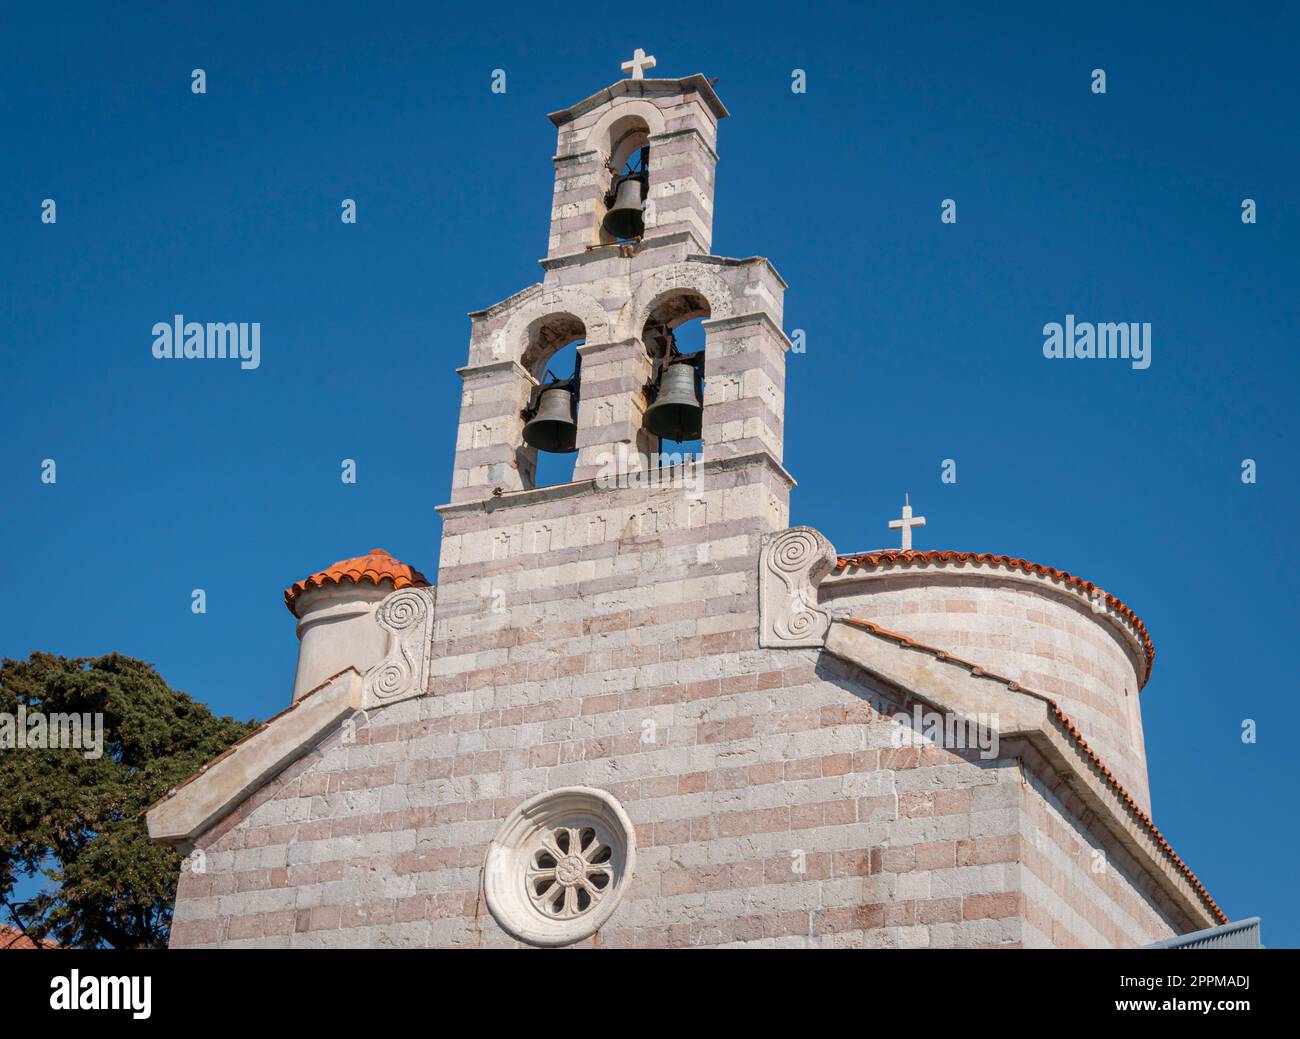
[0,3,1300,945]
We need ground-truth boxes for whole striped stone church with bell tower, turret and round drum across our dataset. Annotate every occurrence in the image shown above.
[147,52,1226,948]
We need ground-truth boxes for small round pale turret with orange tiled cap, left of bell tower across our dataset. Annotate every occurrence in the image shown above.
[285,549,429,704]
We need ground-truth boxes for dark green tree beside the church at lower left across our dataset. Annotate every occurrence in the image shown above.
[0,653,256,948]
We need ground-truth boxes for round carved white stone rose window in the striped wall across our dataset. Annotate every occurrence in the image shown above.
[484,787,636,945]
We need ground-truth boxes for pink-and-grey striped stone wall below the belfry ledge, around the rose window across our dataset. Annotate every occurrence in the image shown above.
[162,499,1190,948]
